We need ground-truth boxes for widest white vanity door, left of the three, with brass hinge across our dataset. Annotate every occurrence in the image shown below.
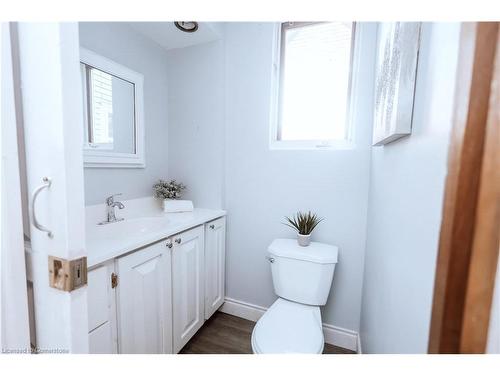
[117,241,172,354]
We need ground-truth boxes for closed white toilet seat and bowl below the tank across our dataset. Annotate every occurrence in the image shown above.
[252,298,324,354]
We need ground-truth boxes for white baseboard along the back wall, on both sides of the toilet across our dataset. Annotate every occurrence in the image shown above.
[219,298,361,353]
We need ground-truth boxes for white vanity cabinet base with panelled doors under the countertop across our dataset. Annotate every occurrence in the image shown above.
[88,216,226,354]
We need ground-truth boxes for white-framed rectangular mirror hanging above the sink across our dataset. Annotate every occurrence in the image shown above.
[80,49,144,168]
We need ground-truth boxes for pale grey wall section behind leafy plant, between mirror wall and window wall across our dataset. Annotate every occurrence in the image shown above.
[168,41,225,208]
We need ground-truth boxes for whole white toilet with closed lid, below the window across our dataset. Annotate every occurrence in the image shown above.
[252,239,338,354]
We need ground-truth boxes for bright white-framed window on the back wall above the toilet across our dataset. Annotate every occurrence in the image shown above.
[271,22,355,148]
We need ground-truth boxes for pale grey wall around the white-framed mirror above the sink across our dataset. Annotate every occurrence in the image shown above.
[79,22,168,205]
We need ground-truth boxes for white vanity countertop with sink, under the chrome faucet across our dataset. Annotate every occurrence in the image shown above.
[86,197,226,268]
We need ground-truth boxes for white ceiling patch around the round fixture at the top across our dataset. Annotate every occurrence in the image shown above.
[128,22,222,50]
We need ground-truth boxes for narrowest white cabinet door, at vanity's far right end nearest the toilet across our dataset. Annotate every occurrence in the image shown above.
[205,217,226,319]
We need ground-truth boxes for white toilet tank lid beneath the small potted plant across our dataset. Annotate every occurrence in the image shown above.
[268,238,339,264]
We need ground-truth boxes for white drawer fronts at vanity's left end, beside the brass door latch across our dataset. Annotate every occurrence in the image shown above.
[87,260,118,354]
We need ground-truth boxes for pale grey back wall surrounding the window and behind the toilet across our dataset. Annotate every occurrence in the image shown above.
[225,23,376,331]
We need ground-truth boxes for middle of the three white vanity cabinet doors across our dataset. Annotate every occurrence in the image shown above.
[172,226,205,353]
